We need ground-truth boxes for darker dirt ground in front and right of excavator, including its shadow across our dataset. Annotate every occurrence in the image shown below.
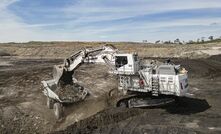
[55,55,221,134]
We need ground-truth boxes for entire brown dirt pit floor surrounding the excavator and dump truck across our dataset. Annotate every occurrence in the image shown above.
[0,42,221,134]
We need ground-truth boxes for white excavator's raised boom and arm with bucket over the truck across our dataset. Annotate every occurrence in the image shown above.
[53,45,118,84]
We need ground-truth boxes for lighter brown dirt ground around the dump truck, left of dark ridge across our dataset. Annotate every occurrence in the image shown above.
[0,58,116,133]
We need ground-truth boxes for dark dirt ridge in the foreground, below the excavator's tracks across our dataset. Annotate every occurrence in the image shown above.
[51,108,145,134]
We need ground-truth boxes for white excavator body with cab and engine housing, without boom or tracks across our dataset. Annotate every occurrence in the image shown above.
[111,54,188,96]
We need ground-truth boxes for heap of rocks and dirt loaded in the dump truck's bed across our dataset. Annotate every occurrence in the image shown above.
[55,83,85,102]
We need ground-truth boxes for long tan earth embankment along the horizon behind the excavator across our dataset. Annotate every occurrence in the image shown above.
[0,42,220,59]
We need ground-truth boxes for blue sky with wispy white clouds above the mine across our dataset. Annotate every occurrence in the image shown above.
[0,0,221,42]
